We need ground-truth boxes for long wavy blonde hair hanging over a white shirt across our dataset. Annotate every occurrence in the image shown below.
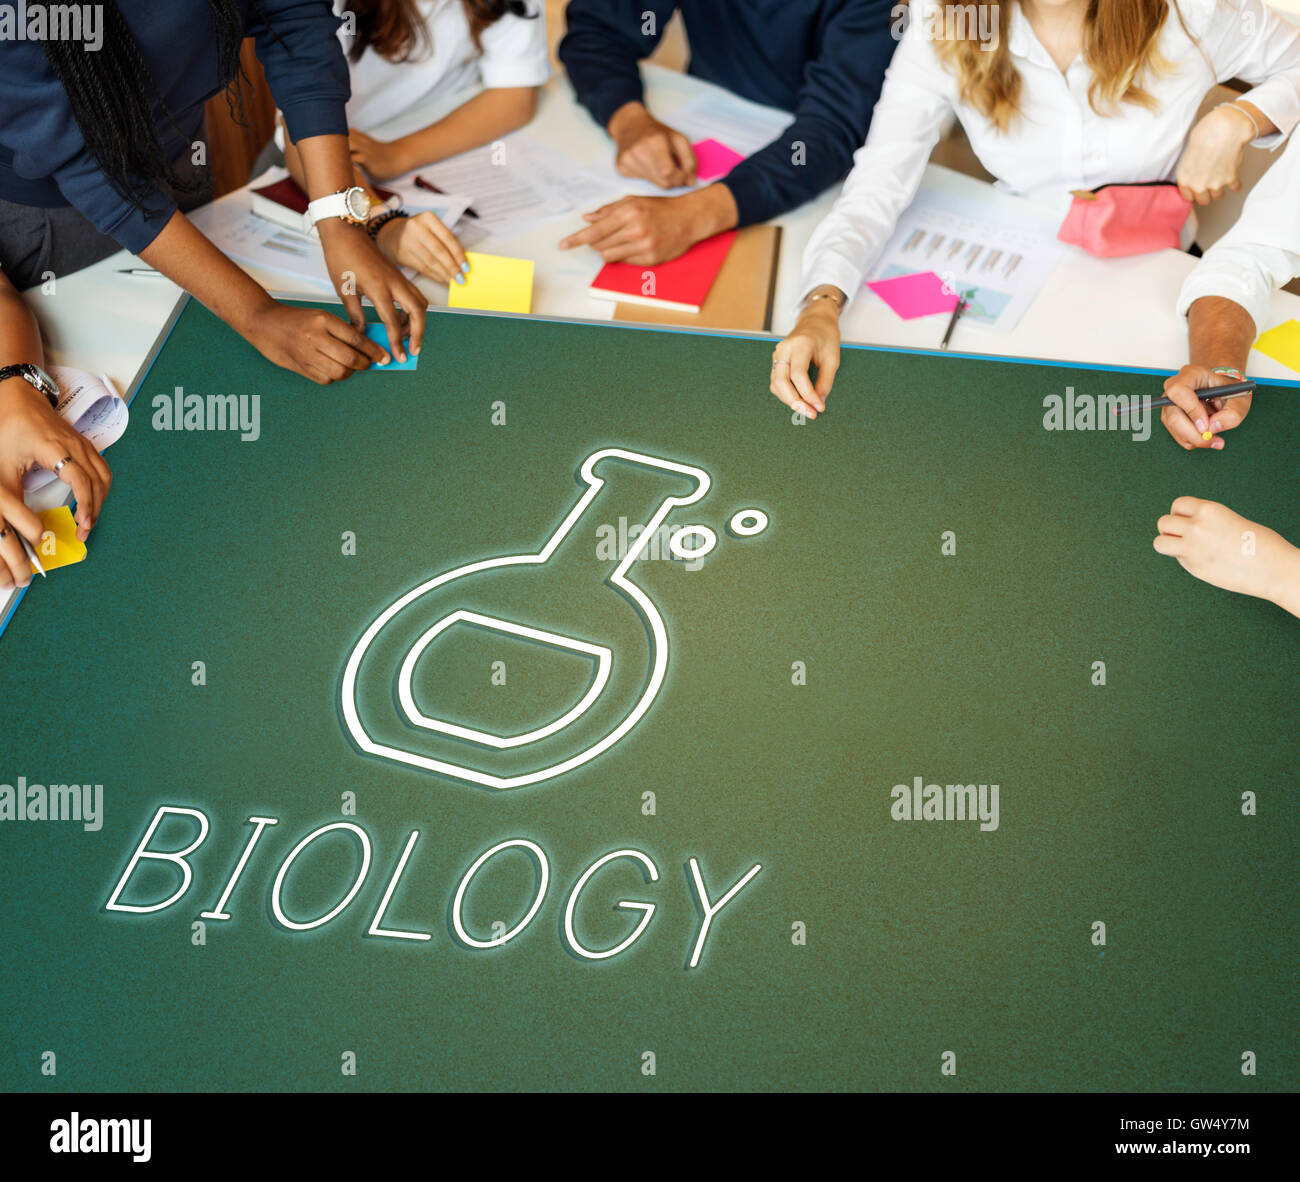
[935,0,1187,131]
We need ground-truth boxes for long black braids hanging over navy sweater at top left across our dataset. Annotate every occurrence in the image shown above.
[38,0,244,209]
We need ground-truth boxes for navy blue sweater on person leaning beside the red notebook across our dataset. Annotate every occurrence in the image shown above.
[560,0,896,225]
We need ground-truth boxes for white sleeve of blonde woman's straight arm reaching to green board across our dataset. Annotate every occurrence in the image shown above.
[800,0,957,303]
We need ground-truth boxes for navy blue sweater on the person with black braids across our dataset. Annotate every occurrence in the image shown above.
[0,0,351,254]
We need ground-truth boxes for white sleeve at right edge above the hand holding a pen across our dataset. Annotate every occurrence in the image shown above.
[1178,134,1300,333]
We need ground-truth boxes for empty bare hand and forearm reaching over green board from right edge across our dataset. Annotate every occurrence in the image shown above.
[1153,497,1300,610]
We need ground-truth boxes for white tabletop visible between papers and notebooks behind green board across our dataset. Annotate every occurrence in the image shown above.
[0,62,1300,620]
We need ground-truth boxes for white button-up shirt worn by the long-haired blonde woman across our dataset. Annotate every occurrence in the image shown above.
[800,0,1300,299]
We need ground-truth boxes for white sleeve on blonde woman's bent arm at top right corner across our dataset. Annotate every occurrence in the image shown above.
[1201,0,1300,148]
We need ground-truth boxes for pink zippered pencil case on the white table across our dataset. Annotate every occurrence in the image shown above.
[1057,181,1192,259]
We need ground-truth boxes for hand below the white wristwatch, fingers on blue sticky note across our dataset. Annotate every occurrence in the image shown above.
[317,217,429,361]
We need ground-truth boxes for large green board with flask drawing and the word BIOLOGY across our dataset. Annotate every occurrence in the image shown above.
[0,303,1300,1091]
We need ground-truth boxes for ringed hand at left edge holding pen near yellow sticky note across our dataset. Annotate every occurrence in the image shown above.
[0,377,113,577]
